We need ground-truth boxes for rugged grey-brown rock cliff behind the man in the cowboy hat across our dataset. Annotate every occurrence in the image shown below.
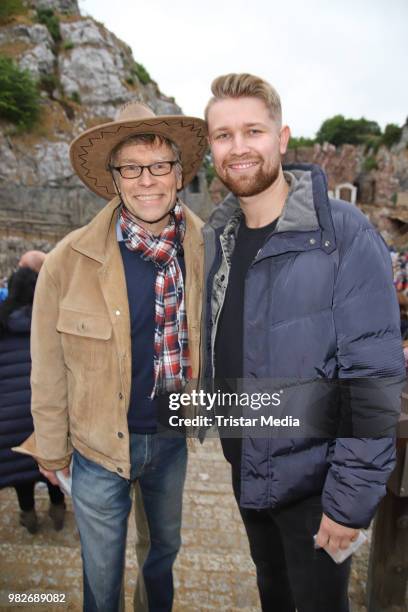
[0,0,211,276]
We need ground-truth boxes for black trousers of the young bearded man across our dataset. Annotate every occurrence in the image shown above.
[233,476,351,612]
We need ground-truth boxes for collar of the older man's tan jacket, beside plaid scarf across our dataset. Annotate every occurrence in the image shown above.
[72,196,203,264]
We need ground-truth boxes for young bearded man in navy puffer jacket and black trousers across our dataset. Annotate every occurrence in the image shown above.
[205,74,404,612]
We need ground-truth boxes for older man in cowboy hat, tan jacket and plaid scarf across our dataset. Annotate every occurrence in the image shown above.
[17,103,206,612]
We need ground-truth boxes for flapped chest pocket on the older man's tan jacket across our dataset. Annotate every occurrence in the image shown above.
[57,308,112,376]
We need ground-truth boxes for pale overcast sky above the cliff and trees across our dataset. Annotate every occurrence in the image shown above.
[79,0,408,137]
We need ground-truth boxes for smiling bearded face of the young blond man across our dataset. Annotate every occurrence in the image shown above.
[207,97,290,197]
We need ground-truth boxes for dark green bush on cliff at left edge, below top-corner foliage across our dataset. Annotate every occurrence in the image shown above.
[0,55,40,130]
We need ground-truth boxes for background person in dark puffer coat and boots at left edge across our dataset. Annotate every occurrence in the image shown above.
[0,267,65,534]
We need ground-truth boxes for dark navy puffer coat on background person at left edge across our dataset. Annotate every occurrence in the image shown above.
[0,306,40,489]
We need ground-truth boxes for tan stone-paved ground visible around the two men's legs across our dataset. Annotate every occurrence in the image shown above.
[0,439,404,612]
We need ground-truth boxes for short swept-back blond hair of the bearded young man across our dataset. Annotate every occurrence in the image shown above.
[204,73,282,126]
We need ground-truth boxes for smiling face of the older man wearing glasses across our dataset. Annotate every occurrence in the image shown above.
[114,143,182,234]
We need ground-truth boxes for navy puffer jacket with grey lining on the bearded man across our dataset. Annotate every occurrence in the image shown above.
[203,165,405,527]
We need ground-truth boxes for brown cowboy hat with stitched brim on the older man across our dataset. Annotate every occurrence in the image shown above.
[70,102,207,200]
